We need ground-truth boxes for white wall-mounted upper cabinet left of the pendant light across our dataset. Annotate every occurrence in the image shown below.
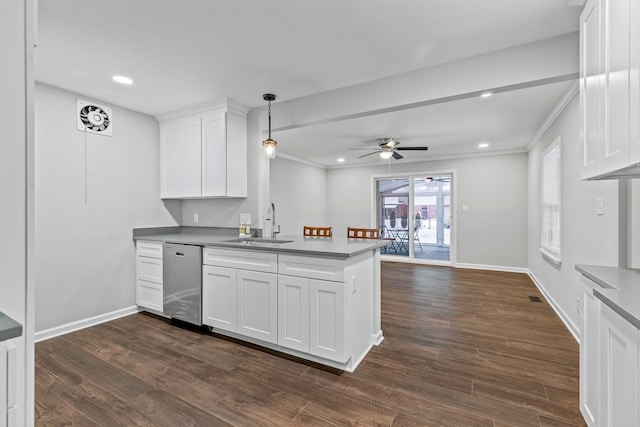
[157,100,248,199]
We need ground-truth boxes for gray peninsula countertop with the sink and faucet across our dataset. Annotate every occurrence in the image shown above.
[133,227,388,259]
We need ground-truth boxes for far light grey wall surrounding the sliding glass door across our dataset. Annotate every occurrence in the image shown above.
[327,153,527,270]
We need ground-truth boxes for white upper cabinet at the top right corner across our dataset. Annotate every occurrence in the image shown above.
[580,0,640,179]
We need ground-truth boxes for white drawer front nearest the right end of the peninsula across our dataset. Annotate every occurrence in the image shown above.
[278,255,347,282]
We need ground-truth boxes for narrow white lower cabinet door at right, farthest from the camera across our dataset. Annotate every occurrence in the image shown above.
[580,288,600,427]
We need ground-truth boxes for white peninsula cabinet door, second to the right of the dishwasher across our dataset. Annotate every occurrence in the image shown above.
[237,270,278,344]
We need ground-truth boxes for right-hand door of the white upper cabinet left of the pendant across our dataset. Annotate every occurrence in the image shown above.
[202,110,227,197]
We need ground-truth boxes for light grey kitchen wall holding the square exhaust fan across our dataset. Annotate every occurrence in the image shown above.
[35,84,181,332]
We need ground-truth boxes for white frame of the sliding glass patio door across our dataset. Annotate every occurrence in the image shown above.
[370,169,458,267]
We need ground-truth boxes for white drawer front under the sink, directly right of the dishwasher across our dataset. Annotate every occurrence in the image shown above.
[202,248,278,273]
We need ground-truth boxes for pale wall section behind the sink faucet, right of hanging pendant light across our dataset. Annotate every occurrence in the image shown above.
[272,157,330,236]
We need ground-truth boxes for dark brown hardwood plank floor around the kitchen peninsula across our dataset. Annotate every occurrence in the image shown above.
[35,263,584,427]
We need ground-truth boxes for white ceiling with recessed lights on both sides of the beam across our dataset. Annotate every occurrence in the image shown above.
[35,0,581,166]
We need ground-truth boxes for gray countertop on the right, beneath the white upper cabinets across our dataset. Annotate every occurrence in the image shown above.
[576,264,640,329]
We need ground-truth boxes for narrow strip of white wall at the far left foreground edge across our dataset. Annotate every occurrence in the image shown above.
[0,0,35,426]
